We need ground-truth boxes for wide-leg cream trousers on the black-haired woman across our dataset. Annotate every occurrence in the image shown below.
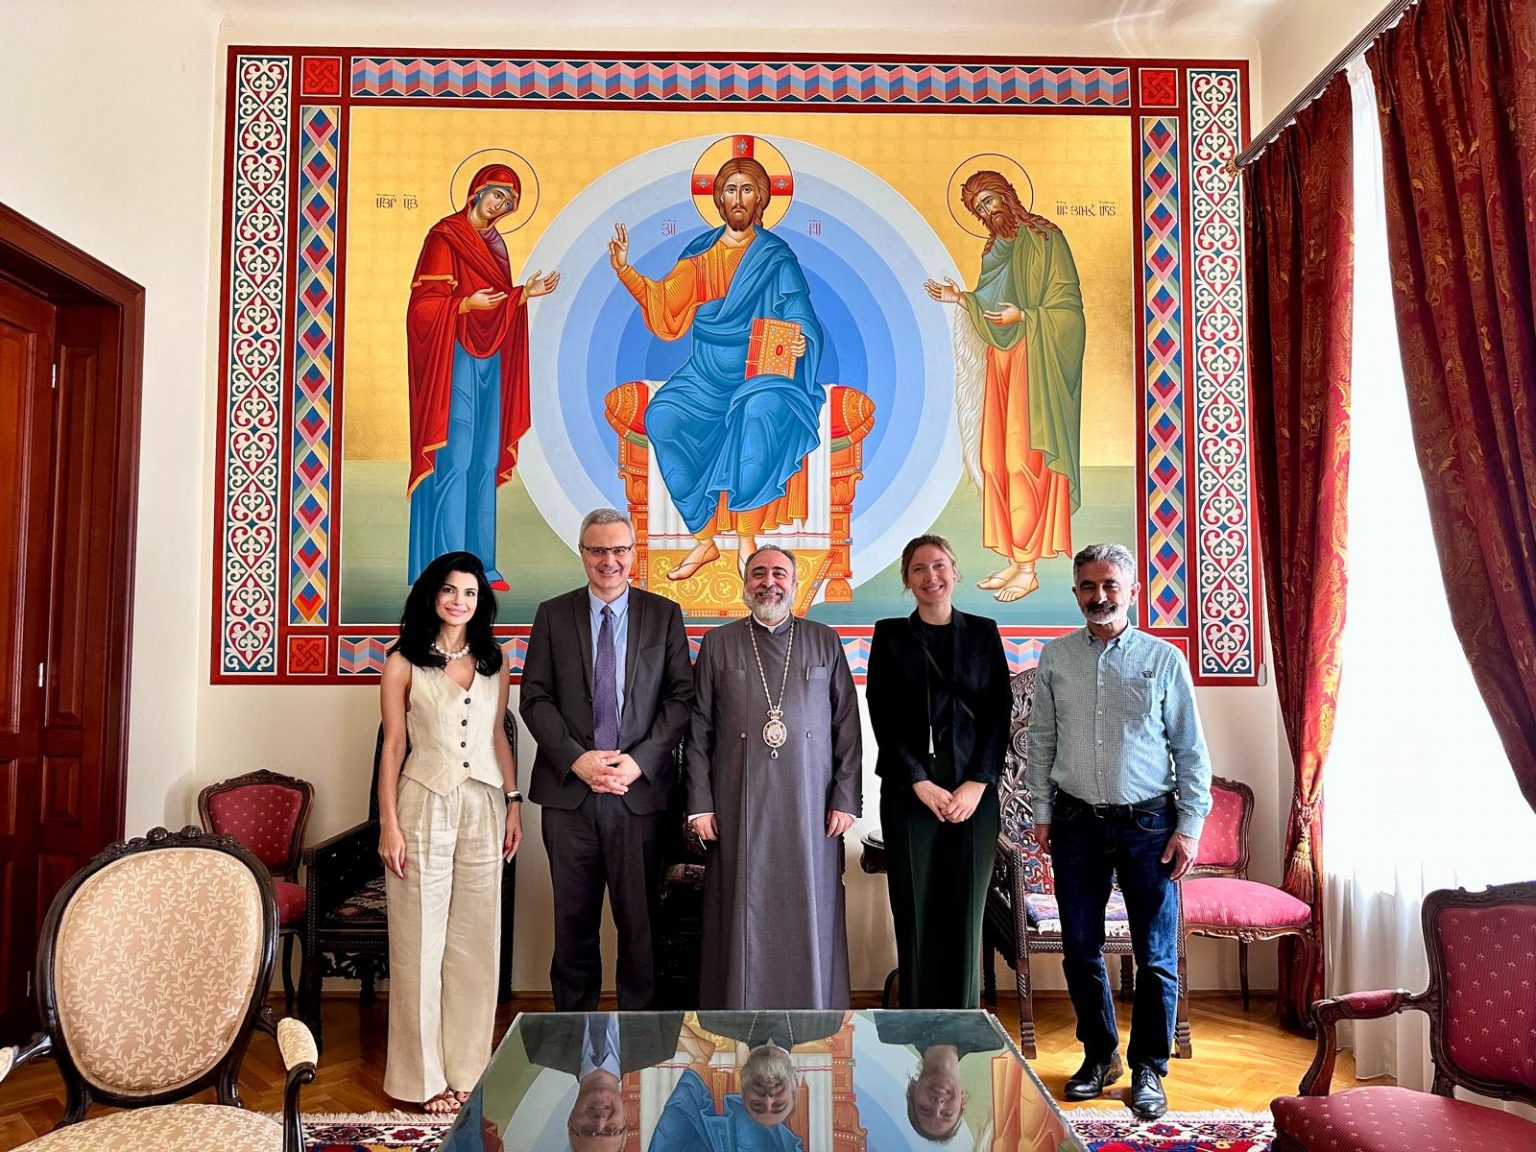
[384,777,507,1101]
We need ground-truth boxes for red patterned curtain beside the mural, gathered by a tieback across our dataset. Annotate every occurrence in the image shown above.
[1244,75,1355,1028]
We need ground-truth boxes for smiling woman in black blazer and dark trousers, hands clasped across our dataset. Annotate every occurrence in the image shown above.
[866,536,1012,1008]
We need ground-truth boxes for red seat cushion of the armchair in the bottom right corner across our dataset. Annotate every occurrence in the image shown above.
[1270,1087,1536,1152]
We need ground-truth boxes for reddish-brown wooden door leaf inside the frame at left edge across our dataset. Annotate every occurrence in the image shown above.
[0,274,57,1035]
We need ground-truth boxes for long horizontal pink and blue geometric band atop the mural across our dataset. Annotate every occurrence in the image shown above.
[352,57,1130,108]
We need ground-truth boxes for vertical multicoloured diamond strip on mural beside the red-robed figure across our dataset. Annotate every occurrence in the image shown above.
[289,106,341,624]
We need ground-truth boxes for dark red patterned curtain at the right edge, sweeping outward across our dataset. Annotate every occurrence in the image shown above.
[1367,0,1536,808]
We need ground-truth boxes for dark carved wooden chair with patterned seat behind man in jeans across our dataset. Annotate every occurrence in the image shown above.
[982,668,1190,1058]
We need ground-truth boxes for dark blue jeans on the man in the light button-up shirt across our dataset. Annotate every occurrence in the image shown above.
[1051,793,1178,1075]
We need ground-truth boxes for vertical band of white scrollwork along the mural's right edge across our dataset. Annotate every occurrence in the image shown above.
[1189,68,1260,680]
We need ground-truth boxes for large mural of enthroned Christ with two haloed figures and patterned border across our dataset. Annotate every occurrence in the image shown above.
[214,48,1260,684]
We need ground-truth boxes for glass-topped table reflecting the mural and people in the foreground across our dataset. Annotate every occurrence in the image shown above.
[442,1011,1084,1152]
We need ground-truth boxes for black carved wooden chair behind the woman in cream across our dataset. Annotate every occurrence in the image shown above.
[300,710,518,1040]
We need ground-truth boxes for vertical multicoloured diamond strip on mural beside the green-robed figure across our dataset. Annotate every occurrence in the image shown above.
[1141,117,1189,628]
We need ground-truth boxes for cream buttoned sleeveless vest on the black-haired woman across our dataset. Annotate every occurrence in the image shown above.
[401,665,502,796]
